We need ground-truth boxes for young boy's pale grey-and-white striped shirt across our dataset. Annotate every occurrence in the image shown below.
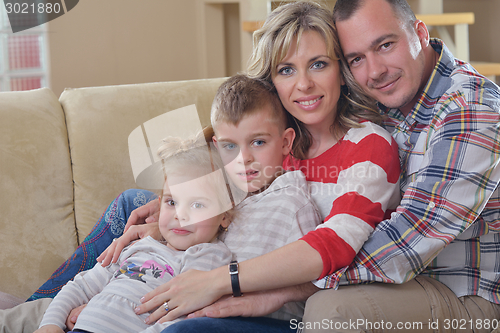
[220,171,321,320]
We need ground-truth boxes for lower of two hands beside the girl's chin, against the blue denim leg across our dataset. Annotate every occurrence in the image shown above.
[97,222,161,267]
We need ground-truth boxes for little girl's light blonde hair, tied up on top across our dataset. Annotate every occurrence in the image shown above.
[158,133,233,222]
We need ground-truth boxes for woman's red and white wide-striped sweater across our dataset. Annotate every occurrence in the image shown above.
[283,122,400,279]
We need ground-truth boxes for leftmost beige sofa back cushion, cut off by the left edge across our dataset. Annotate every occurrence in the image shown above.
[0,89,77,299]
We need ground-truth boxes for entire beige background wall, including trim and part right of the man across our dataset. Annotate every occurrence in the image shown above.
[48,0,500,95]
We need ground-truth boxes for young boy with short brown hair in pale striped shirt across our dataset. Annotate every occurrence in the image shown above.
[211,75,322,320]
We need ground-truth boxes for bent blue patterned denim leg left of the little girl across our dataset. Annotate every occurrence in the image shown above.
[28,189,156,301]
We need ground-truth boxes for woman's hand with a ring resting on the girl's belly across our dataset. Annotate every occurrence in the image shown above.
[136,266,226,324]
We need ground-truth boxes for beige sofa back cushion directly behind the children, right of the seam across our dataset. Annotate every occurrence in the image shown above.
[59,79,224,242]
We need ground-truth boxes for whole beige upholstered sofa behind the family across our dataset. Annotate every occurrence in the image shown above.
[0,78,224,307]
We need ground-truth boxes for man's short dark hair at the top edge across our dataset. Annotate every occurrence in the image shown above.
[333,0,417,27]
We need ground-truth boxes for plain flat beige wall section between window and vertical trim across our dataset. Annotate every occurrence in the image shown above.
[48,0,200,95]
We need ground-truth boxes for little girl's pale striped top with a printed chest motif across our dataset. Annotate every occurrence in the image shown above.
[40,237,231,333]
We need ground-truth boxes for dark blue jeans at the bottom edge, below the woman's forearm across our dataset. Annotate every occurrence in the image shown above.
[161,317,296,333]
